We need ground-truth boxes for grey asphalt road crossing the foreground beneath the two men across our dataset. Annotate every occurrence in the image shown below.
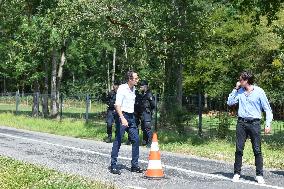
[0,126,284,189]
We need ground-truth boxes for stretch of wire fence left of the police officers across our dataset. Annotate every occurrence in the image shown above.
[0,93,107,121]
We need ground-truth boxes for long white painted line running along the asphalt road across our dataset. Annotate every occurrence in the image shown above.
[0,133,284,189]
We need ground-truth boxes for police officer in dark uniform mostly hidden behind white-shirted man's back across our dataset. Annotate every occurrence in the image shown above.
[105,81,119,143]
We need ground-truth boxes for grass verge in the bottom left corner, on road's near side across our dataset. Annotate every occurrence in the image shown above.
[0,156,115,189]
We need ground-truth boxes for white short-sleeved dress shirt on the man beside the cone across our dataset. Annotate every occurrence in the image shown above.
[115,83,136,113]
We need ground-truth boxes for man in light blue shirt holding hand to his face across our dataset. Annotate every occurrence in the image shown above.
[227,71,273,184]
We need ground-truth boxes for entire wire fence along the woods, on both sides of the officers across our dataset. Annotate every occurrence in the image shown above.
[0,92,284,137]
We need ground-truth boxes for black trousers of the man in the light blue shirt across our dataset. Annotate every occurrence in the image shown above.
[234,118,263,176]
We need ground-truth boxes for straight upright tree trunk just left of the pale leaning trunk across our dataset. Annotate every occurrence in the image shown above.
[50,48,58,118]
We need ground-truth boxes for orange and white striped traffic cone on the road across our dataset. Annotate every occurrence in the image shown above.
[145,133,165,179]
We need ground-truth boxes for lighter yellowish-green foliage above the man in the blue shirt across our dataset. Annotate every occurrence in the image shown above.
[184,4,283,100]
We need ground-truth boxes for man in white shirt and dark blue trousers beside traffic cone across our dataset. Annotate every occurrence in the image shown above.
[110,71,143,175]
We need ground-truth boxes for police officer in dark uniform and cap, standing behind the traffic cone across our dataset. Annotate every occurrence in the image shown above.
[140,80,155,147]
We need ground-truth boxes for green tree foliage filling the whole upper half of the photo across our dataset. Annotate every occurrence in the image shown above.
[0,0,284,102]
